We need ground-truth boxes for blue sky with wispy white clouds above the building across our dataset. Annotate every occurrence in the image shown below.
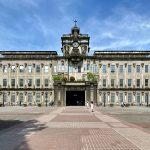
[0,0,150,53]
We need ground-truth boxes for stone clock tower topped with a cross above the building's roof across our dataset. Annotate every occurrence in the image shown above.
[61,21,90,59]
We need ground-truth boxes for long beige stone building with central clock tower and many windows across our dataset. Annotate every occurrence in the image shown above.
[0,23,150,106]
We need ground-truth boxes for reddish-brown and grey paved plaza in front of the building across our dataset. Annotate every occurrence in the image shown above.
[0,106,150,150]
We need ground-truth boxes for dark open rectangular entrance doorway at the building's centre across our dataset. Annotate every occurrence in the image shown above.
[66,91,85,106]
